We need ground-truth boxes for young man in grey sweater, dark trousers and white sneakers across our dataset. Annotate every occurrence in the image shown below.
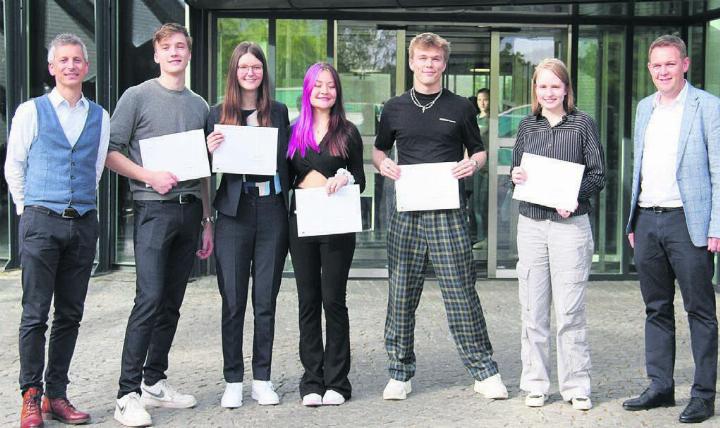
[106,24,213,426]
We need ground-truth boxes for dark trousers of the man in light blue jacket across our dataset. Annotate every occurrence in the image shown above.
[635,210,718,400]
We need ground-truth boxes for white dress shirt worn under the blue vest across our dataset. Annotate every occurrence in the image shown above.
[5,89,110,215]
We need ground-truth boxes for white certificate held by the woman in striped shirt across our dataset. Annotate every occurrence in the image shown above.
[513,153,585,211]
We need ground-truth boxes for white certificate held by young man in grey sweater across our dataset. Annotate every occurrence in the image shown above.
[140,129,210,181]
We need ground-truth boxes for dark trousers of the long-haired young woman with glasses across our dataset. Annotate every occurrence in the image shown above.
[215,194,288,382]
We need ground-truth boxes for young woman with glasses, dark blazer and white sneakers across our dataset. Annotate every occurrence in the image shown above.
[206,42,290,408]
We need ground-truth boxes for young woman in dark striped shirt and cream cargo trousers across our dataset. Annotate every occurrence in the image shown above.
[511,58,605,410]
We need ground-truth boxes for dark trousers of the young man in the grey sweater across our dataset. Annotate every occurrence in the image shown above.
[118,200,202,398]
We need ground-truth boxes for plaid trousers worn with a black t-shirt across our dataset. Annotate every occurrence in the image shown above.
[385,209,498,381]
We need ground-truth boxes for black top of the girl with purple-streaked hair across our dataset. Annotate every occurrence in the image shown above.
[290,123,365,192]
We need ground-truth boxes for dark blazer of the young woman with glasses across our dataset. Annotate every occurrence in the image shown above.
[205,101,290,217]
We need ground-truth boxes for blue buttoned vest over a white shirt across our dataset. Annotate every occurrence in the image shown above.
[25,95,103,215]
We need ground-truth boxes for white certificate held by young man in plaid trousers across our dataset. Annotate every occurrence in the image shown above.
[395,162,460,212]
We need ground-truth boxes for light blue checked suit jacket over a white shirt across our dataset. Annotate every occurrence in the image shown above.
[626,82,720,247]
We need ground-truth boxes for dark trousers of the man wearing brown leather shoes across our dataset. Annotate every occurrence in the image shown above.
[19,206,98,398]
